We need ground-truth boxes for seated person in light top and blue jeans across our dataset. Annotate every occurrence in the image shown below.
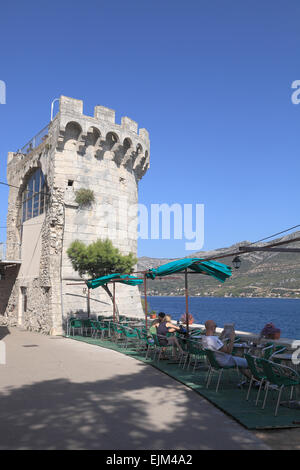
[202,320,251,379]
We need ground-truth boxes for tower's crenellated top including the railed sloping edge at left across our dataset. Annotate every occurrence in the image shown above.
[8,96,150,180]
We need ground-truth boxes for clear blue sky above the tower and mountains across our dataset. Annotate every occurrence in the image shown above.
[0,0,300,257]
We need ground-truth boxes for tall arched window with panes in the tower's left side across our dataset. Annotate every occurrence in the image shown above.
[22,168,47,223]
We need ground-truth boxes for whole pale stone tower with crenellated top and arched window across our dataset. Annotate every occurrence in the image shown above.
[0,96,149,334]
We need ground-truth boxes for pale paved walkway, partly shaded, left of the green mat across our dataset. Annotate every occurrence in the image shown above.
[0,328,266,450]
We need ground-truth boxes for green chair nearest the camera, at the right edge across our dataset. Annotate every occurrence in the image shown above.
[260,359,300,416]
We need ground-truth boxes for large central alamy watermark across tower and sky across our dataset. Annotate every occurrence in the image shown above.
[98,199,204,250]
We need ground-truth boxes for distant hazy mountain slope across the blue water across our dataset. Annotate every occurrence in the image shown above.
[138,231,300,298]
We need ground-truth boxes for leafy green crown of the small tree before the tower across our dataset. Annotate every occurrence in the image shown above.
[67,239,137,279]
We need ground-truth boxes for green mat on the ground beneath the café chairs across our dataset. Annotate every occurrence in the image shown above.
[68,335,300,429]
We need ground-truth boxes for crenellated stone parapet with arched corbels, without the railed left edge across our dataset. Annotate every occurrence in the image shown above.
[55,96,150,180]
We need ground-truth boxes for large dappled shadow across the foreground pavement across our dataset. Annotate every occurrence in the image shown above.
[0,364,259,450]
